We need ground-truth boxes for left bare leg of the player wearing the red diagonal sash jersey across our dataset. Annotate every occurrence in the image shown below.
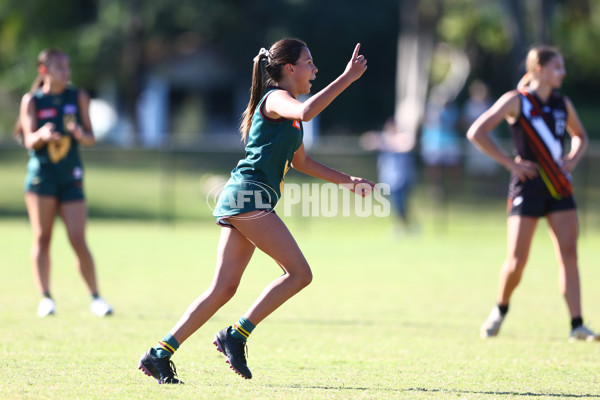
[497,215,537,305]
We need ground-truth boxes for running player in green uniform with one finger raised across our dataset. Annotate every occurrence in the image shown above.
[139,39,373,383]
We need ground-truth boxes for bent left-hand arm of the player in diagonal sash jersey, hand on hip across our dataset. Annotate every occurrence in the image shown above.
[467,90,537,181]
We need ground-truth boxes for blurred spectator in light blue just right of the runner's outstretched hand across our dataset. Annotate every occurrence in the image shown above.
[360,118,417,233]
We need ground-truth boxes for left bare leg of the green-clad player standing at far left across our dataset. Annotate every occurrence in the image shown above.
[25,192,57,293]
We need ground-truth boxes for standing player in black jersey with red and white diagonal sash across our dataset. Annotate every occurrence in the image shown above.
[467,46,598,341]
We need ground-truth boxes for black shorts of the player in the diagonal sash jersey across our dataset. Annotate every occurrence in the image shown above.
[507,176,577,217]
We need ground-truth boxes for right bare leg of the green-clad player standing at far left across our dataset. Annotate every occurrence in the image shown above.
[58,200,98,294]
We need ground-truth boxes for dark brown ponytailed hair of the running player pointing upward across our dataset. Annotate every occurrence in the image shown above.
[240,38,307,141]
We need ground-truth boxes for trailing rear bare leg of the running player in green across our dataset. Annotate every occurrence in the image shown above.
[170,228,255,344]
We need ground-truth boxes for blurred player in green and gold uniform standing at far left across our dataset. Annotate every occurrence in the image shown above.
[15,49,112,317]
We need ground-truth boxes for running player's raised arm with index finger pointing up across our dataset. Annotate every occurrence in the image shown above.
[265,43,367,121]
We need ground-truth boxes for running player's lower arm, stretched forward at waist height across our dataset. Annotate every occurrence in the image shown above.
[292,144,375,196]
